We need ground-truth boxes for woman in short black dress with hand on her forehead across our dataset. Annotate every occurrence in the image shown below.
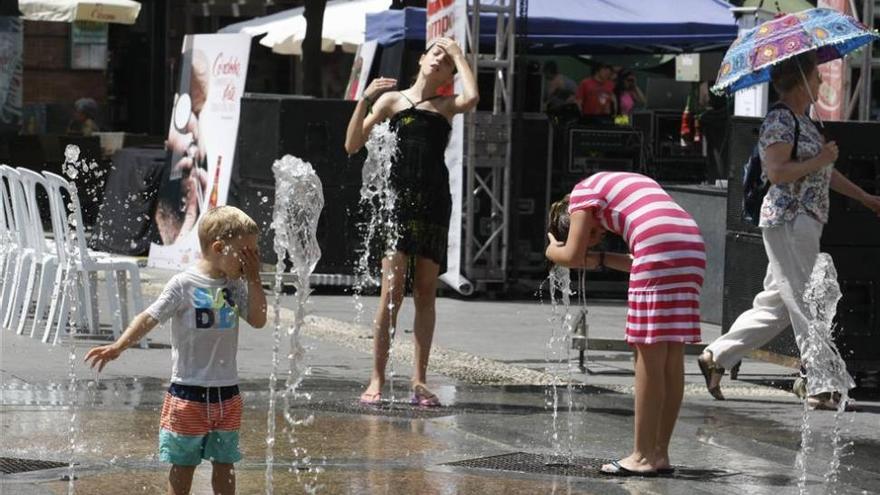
[345,38,479,406]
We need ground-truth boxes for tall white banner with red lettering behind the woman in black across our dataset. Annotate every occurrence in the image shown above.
[425,0,472,292]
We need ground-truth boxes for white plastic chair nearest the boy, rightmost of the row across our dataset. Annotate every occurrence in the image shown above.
[43,172,147,347]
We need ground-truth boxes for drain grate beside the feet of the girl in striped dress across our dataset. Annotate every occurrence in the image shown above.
[445,452,611,478]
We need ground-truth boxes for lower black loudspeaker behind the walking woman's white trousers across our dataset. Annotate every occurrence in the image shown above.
[722,232,880,371]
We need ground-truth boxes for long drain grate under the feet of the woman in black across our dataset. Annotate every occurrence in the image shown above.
[294,399,545,419]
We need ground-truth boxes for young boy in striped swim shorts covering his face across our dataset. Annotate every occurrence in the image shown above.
[85,206,266,495]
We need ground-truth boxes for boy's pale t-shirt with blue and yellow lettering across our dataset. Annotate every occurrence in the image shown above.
[146,268,247,387]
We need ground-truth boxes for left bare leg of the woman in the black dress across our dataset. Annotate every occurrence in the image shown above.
[364,253,407,395]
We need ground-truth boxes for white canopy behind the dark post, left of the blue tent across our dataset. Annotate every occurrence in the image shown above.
[220,0,390,55]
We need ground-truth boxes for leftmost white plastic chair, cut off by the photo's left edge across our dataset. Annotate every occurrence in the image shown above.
[0,165,35,329]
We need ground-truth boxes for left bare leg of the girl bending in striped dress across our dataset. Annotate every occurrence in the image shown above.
[602,342,668,471]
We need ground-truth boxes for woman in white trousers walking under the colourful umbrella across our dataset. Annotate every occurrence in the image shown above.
[698,52,880,409]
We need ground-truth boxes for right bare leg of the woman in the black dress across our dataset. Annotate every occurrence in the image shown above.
[412,257,440,388]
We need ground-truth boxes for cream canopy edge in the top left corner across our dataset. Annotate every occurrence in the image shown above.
[18,0,141,24]
